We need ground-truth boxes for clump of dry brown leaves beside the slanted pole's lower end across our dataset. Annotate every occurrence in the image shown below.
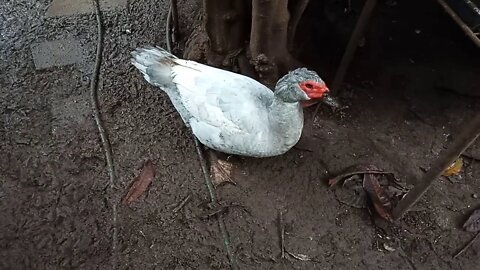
[328,164,407,222]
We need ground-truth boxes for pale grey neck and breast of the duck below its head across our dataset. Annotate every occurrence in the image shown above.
[268,97,303,147]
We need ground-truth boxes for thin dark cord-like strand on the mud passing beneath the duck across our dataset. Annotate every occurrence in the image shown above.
[166,6,238,270]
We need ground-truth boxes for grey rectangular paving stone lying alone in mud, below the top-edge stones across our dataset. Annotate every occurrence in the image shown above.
[30,38,84,69]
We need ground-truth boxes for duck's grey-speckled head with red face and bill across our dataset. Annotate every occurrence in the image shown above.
[275,68,339,107]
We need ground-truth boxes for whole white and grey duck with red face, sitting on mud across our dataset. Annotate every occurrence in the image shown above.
[132,47,337,157]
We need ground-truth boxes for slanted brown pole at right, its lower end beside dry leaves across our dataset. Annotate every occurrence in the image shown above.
[393,113,480,220]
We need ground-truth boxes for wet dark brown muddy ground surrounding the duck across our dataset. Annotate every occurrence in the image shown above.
[0,0,480,269]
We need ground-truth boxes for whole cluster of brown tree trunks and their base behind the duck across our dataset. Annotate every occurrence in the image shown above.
[184,0,309,84]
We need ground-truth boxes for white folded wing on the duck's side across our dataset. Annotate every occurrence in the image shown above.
[172,59,273,135]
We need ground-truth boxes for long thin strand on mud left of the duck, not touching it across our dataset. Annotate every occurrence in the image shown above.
[90,0,118,269]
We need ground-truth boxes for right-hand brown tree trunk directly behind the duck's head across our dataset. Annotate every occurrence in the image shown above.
[250,0,299,86]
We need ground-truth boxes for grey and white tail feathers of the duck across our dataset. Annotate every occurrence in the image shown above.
[131,47,178,88]
